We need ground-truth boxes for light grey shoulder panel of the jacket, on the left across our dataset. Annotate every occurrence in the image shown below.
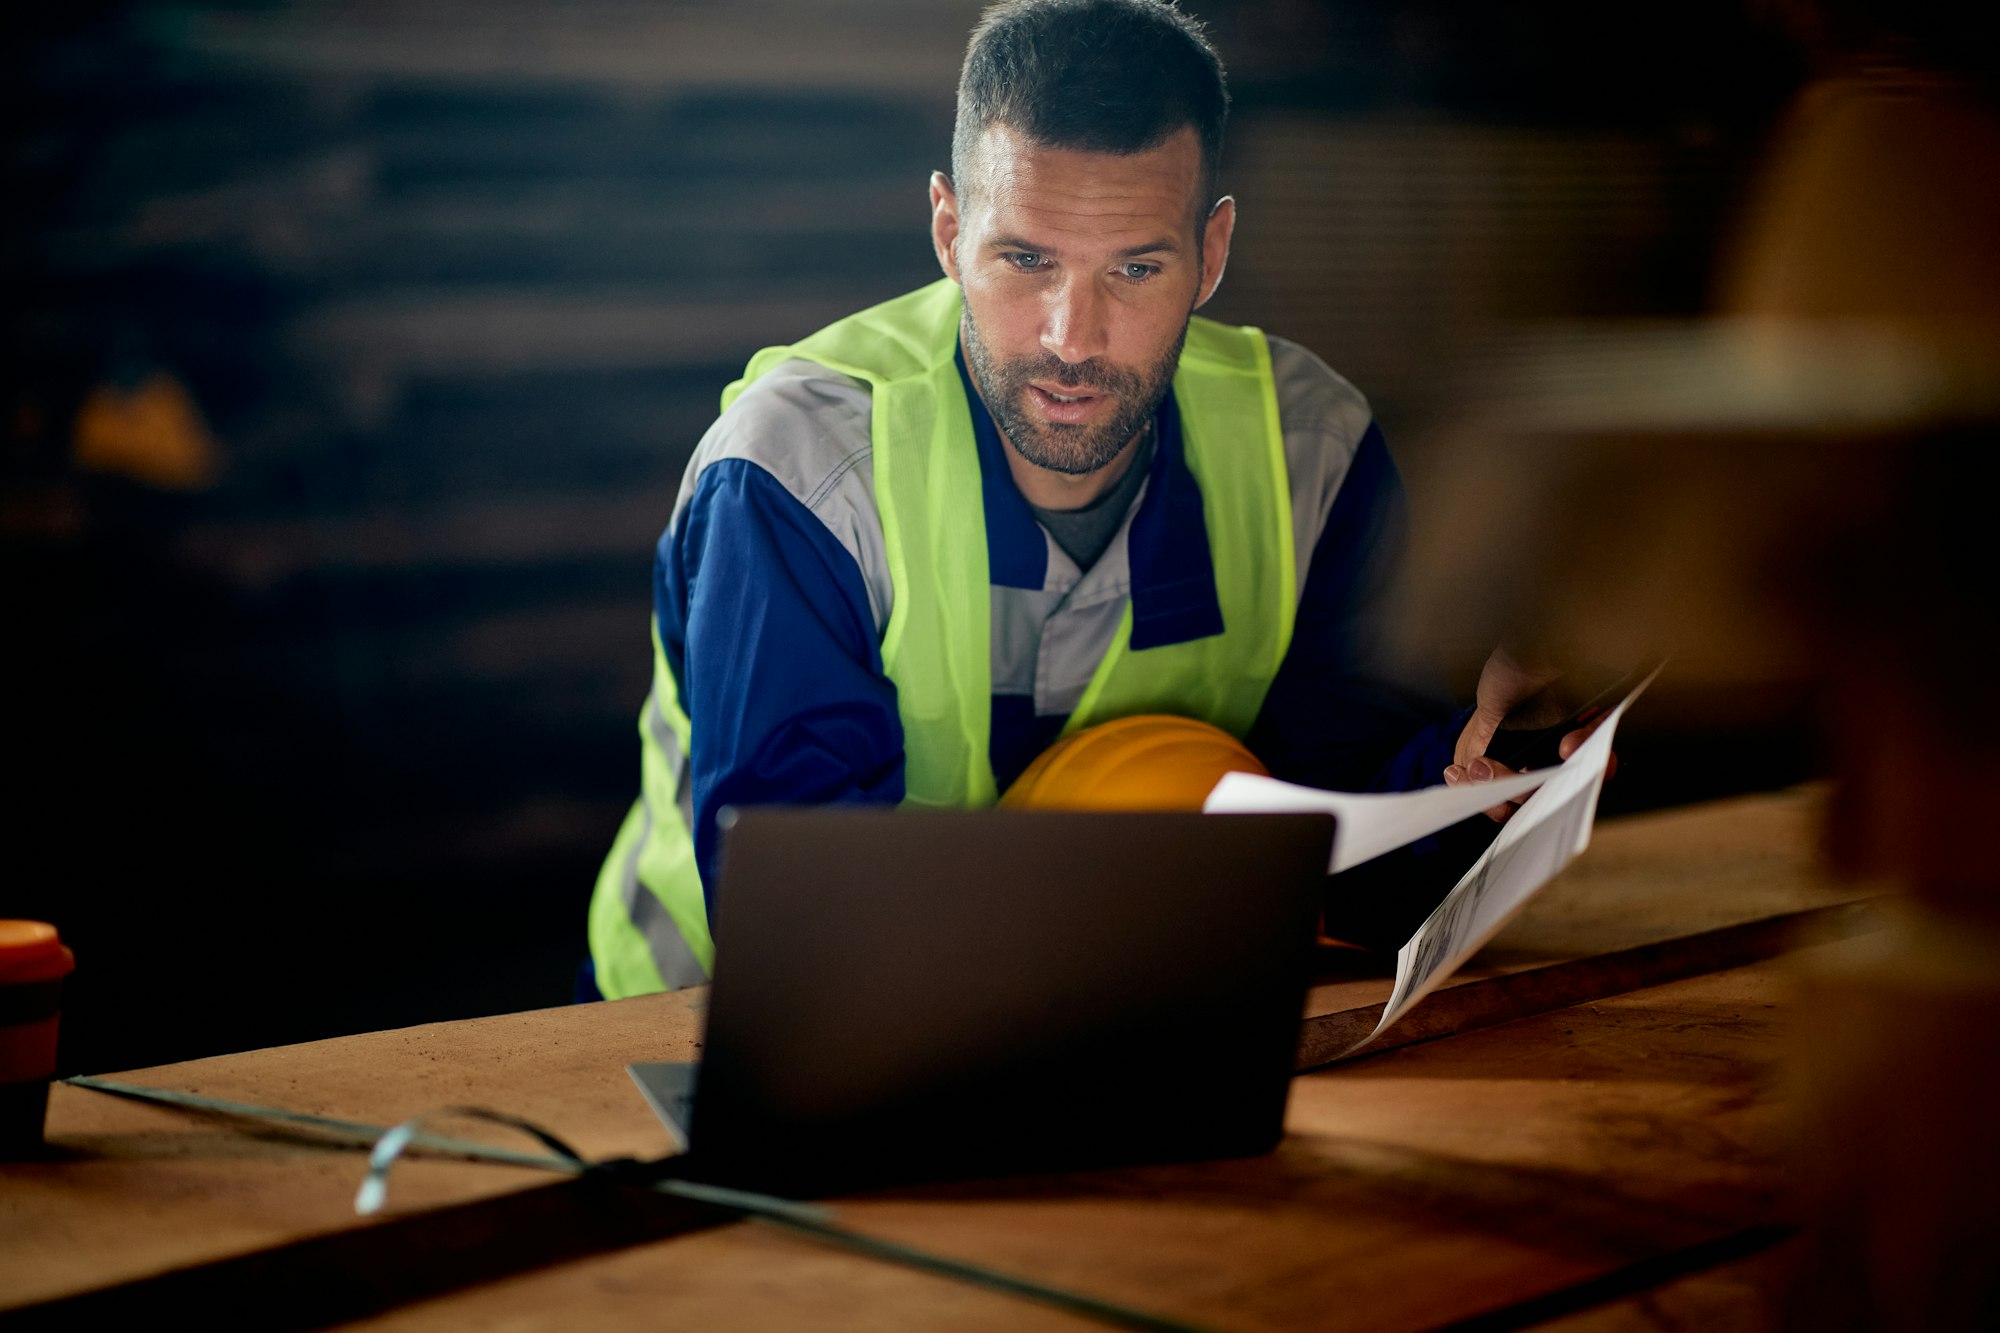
[674,360,894,634]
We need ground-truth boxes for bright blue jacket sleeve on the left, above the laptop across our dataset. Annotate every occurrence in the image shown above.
[654,458,904,913]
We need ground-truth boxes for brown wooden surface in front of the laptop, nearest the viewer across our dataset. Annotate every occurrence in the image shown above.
[324,963,1816,1333]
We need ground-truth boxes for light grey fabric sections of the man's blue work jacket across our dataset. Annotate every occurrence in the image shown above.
[674,338,1370,720]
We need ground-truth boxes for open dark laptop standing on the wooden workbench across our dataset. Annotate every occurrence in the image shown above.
[630,807,1334,1195]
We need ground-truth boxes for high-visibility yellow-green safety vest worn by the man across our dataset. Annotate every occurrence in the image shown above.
[590,280,1298,997]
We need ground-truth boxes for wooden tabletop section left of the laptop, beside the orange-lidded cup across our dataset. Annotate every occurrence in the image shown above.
[0,993,700,1307]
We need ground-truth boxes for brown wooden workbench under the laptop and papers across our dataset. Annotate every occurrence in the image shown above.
[0,793,1858,1331]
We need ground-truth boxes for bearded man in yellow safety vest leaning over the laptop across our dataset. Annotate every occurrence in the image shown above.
[590,0,1540,997]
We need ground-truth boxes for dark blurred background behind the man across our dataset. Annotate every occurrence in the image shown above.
[0,0,1812,1071]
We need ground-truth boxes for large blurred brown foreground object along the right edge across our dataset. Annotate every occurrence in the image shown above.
[1414,57,2000,1329]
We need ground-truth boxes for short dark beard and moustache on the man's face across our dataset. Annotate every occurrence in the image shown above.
[964,306,1188,476]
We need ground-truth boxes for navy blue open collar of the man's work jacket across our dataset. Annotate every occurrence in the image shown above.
[956,348,1222,648]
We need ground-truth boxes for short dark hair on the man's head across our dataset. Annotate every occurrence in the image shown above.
[952,0,1230,217]
